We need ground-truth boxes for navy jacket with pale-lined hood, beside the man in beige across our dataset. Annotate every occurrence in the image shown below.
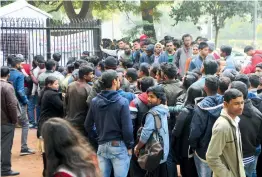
[189,94,223,160]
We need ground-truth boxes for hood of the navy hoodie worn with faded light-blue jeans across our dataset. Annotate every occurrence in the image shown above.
[97,91,121,109]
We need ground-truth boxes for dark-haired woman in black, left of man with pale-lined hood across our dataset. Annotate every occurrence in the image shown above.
[172,85,202,177]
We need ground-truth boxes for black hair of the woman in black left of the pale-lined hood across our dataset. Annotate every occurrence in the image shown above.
[185,85,203,105]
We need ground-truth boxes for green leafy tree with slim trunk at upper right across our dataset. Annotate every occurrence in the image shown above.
[170,1,252,45]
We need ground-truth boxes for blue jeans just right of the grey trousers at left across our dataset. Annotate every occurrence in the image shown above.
[27,95,40,125]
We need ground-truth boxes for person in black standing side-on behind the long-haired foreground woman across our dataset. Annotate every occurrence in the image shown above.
[37,76,63,175]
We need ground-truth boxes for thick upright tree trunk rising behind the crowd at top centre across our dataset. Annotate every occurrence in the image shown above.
[140,1,156,39]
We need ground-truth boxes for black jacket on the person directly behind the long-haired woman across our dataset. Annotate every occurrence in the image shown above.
[37,88,64,136]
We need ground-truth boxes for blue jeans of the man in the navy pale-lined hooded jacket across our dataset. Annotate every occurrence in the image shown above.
[194,154,212,177]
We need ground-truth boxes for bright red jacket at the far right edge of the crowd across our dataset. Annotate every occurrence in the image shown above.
[243,50,262,74]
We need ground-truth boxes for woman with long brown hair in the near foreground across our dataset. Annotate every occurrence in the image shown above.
[42,118,100,177]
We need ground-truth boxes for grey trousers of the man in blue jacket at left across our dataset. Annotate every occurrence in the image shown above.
[19,103,29,150]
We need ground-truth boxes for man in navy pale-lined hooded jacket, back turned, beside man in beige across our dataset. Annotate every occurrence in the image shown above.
[189,76,223,177]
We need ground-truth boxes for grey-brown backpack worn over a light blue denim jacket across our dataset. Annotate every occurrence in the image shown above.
[137,110,164,172]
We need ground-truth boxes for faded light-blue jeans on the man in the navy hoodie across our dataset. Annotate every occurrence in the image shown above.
[97,141,131,177]
